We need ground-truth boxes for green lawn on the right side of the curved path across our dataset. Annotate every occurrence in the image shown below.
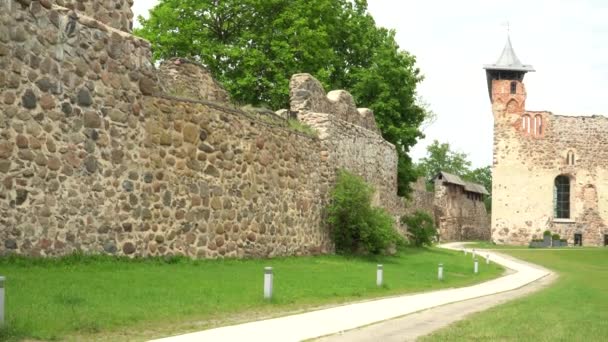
[422,248,608,341]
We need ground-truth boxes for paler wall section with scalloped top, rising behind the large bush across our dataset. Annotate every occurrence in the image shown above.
[290,74,405,216]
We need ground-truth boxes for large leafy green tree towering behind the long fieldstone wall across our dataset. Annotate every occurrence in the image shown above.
[136,0,427,195]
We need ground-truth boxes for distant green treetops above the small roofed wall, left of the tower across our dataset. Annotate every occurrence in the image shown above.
[416,140,492,212]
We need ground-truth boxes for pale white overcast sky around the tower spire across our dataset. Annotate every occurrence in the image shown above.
[133,0,608,167]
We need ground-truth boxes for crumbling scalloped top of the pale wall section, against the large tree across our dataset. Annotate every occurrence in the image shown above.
[289,74,380,133]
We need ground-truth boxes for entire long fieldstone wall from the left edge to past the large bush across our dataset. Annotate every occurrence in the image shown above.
[0,0,428,257]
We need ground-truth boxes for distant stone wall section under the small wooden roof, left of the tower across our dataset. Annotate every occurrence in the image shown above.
[434,180,491,242]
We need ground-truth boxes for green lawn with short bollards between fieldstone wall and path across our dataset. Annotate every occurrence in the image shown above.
[0,248,503,340]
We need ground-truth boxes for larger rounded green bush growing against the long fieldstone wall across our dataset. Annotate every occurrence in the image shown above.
[327,170,403,254]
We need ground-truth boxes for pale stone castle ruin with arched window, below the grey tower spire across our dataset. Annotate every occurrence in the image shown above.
[492,81,608,245]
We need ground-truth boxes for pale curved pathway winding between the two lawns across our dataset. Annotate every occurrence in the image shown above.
[151,243,552,342]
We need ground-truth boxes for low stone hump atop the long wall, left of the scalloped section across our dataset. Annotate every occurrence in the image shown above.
[159,58,230,103]
